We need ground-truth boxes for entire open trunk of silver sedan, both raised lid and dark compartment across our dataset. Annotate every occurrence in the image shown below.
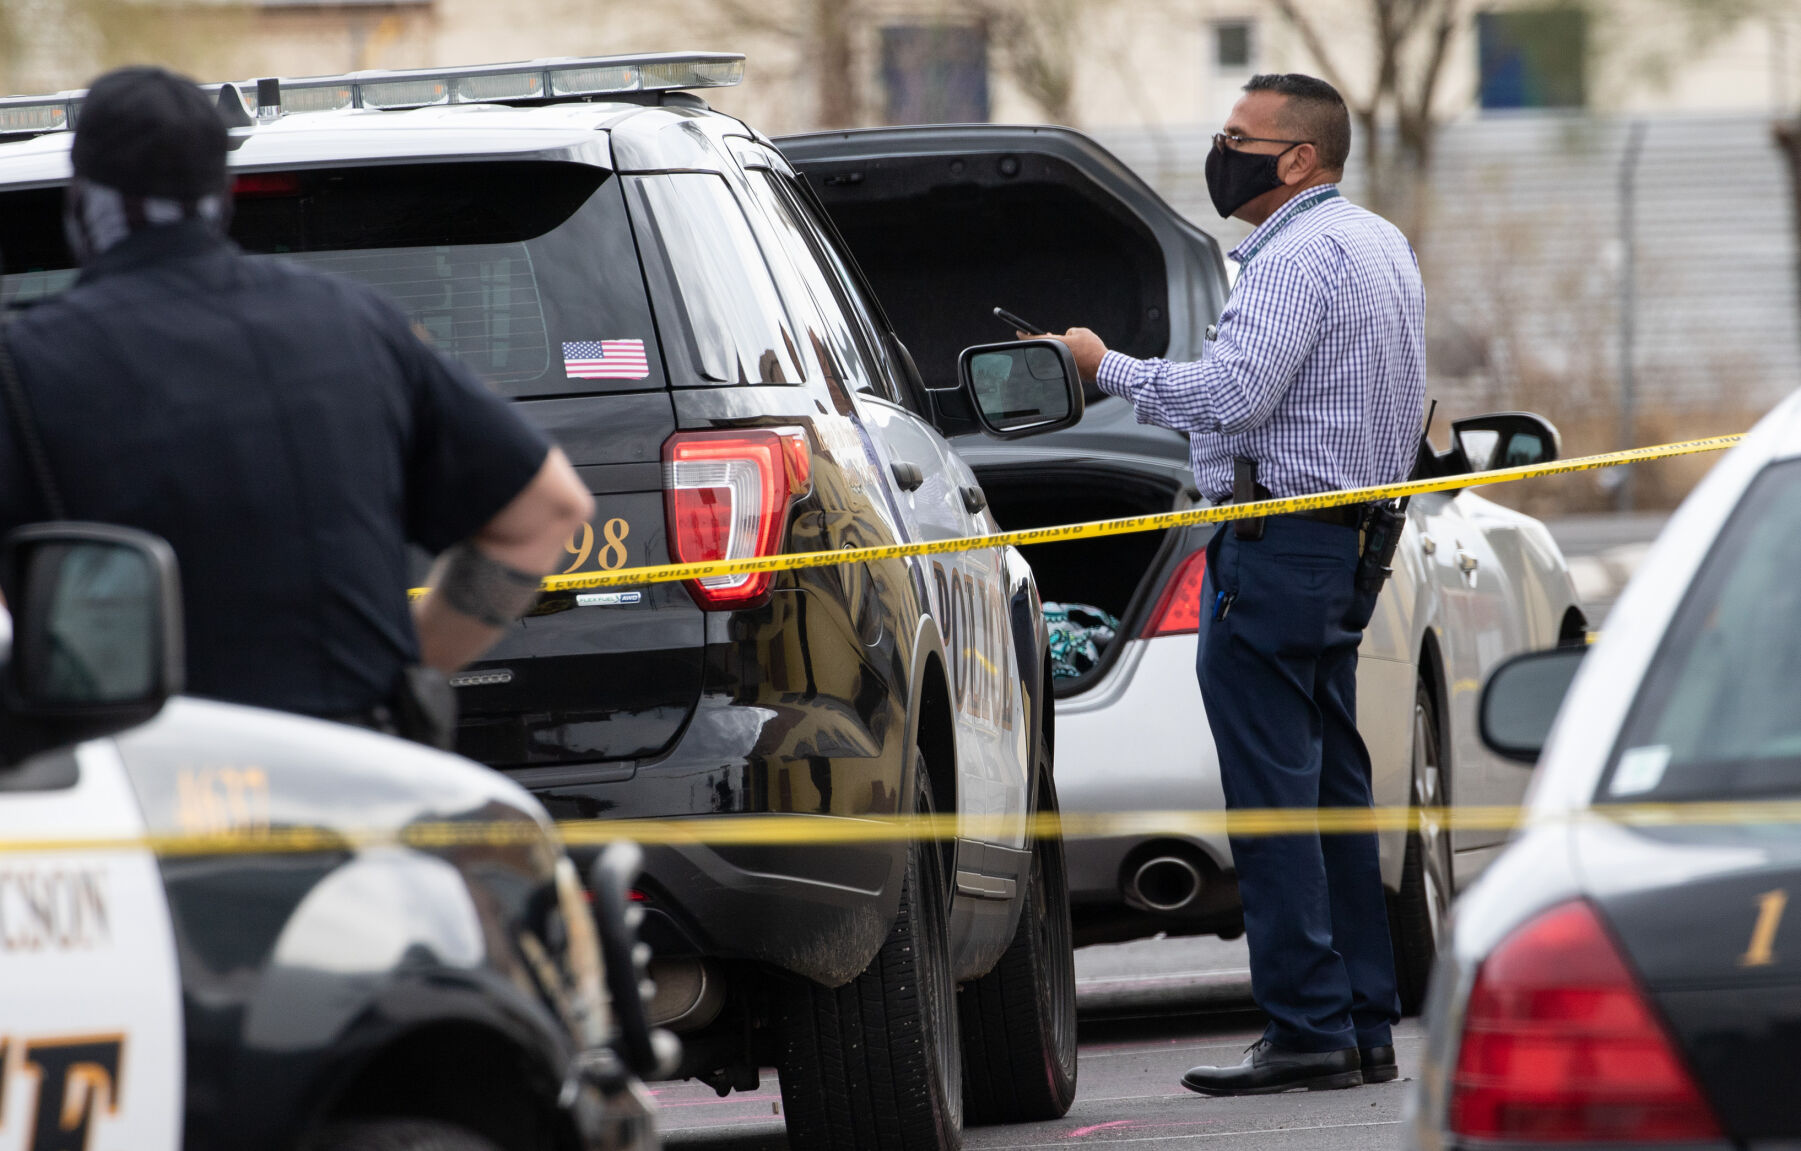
[778,124,1226,697]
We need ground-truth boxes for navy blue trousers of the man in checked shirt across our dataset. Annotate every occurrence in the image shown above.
[1196,517,1401,1052]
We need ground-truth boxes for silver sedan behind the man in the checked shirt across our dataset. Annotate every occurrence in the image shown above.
[962,398,1588,1012]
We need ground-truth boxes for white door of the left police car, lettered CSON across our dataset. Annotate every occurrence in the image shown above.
[0,740,186,1151]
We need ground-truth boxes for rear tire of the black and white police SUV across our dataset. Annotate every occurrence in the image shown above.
[776,757,964,1151]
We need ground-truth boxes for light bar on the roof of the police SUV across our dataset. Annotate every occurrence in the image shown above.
[0,52,744,135]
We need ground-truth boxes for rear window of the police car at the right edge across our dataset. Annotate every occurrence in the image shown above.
[1596,461,1801,803]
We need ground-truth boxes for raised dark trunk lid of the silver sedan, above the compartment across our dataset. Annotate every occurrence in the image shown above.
[778,124,1226,387]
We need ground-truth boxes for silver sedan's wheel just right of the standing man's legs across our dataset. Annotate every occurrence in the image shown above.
[1389,681,1452,1016]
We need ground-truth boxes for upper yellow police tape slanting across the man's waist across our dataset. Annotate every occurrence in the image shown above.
[409,436,1743,598]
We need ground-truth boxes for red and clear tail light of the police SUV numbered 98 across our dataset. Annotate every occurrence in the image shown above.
[663,429,812,609]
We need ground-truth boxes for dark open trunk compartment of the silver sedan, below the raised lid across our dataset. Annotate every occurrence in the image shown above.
[976,461,1194,699]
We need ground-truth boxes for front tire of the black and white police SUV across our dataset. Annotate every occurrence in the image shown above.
[956,757,1077,1124]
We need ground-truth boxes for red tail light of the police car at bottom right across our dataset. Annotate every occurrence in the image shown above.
[1450,901,1722,1144]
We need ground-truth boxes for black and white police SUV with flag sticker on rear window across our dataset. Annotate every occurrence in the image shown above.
[0,54,1082,1147]
